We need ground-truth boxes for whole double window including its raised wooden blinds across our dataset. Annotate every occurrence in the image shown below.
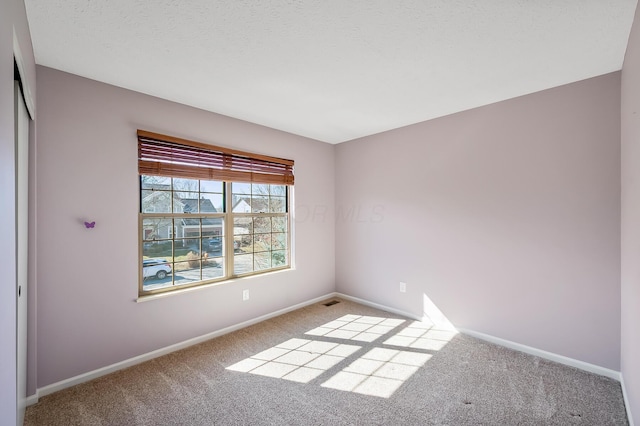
[138,130,293,295]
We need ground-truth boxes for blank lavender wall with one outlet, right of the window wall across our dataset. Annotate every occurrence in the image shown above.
[336,73,620,370]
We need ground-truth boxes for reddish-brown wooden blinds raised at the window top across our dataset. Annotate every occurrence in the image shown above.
[138,130,293,185]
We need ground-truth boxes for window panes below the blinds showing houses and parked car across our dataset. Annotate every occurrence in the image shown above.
[140,175,290,294]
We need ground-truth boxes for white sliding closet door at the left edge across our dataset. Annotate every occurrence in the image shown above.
[14,82,29,425]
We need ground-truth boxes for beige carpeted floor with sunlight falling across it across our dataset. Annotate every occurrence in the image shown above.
[25,300,628,426]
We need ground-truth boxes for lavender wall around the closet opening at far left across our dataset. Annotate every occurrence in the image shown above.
[0,0,35,424]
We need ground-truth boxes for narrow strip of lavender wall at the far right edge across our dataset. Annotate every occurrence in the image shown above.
[621,3,640,420]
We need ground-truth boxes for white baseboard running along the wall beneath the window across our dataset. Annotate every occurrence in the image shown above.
[36,293,336,397]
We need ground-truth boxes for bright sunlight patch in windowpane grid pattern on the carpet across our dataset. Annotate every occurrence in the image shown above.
[227,315,444,398]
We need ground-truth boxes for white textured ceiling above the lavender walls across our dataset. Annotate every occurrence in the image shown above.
[25,0,637,143]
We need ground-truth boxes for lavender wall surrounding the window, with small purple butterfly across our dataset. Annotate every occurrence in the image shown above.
[36,67,335,387]
